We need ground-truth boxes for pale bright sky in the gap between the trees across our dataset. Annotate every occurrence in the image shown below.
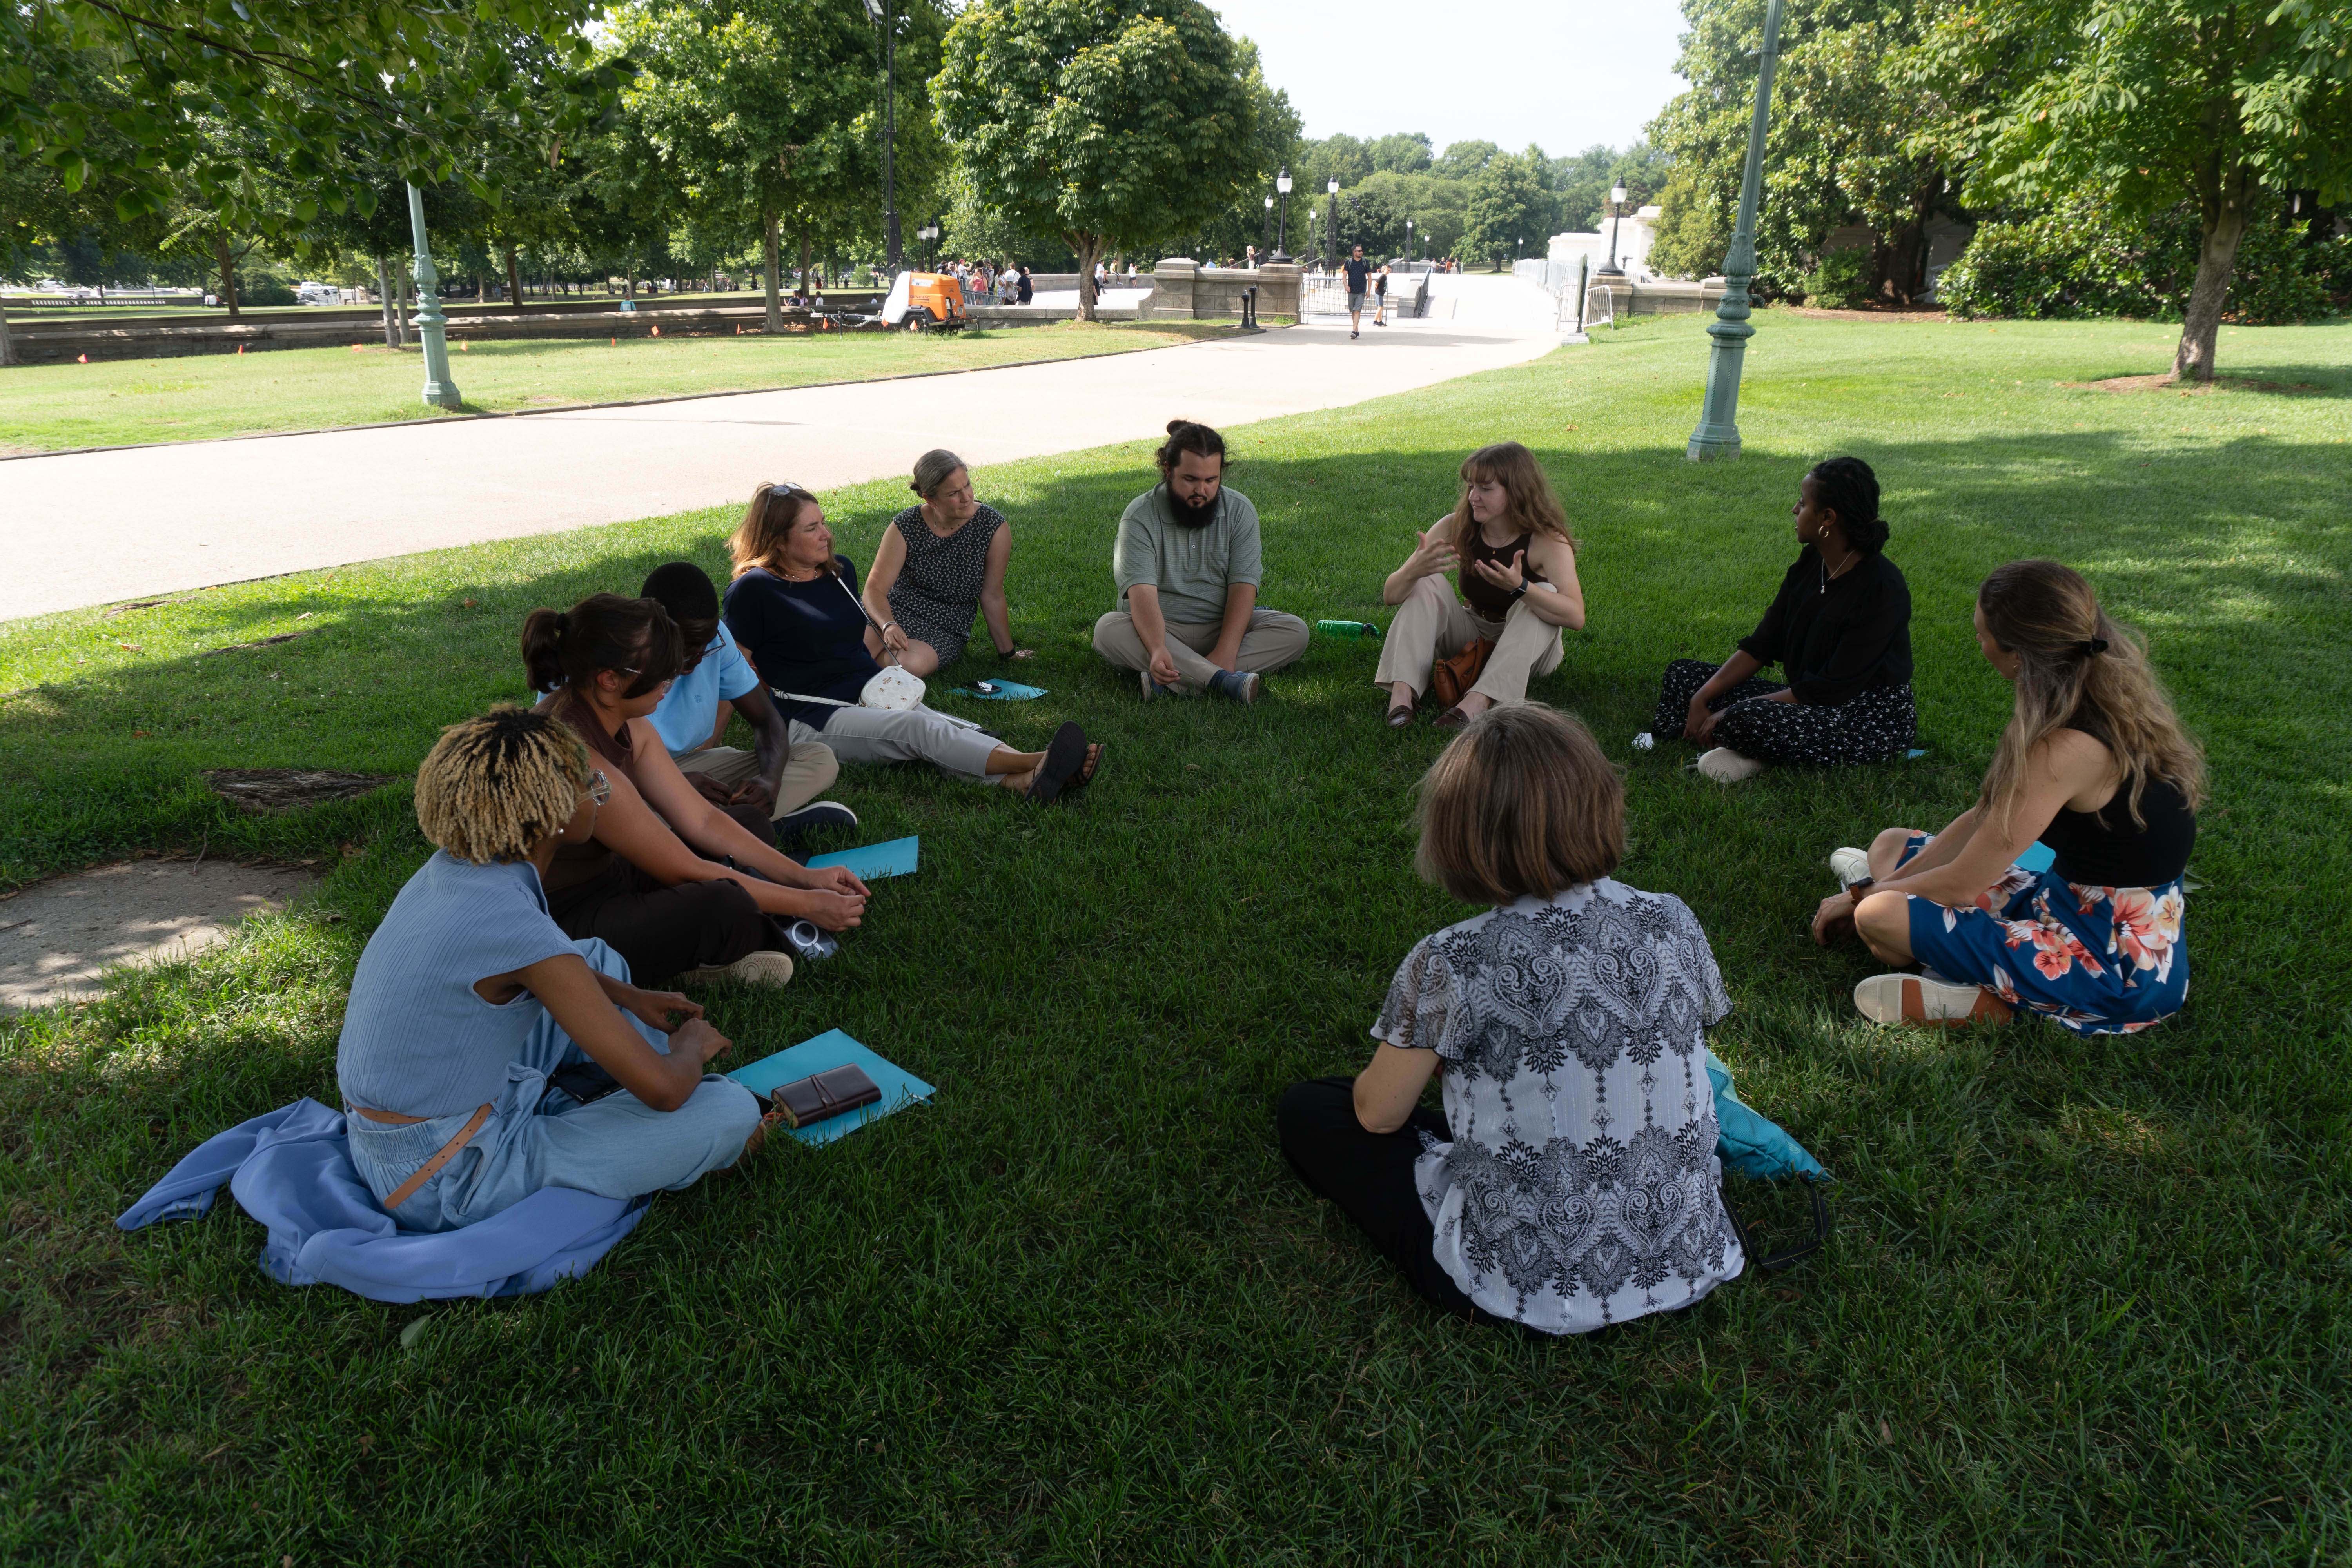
[1209,0,1686,148]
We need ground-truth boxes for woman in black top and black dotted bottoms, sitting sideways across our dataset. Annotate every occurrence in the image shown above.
[1635,458,1919,783]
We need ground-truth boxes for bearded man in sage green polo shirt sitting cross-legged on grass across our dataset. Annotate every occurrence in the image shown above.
[1094,418,1308,703]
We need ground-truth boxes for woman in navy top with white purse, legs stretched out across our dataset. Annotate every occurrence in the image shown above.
[724,484,1103,804]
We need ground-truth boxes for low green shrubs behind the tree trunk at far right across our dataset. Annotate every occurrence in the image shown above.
[1936,205,2352,325]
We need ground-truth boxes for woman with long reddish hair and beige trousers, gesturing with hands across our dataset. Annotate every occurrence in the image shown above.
[1371,442,1585,729]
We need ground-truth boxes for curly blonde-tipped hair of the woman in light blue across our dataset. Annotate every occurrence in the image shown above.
[416,705,588,865]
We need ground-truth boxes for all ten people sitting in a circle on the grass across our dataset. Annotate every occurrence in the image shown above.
[336,421,2204,1333]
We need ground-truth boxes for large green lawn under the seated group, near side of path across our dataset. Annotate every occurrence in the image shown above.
[0,315,2352,1566]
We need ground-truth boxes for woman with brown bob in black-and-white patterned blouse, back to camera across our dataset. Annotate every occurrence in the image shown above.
[1275,703,1748,1333]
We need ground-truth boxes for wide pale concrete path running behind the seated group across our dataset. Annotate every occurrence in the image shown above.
[0,301,1552,621]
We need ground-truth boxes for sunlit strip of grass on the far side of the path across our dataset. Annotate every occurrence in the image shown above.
[0,318,1232,456]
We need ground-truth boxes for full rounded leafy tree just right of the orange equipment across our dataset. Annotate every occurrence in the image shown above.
[931,0,1263,320]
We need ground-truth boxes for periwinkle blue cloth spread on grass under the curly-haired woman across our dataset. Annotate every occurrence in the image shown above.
[115,1100,644,1302]
